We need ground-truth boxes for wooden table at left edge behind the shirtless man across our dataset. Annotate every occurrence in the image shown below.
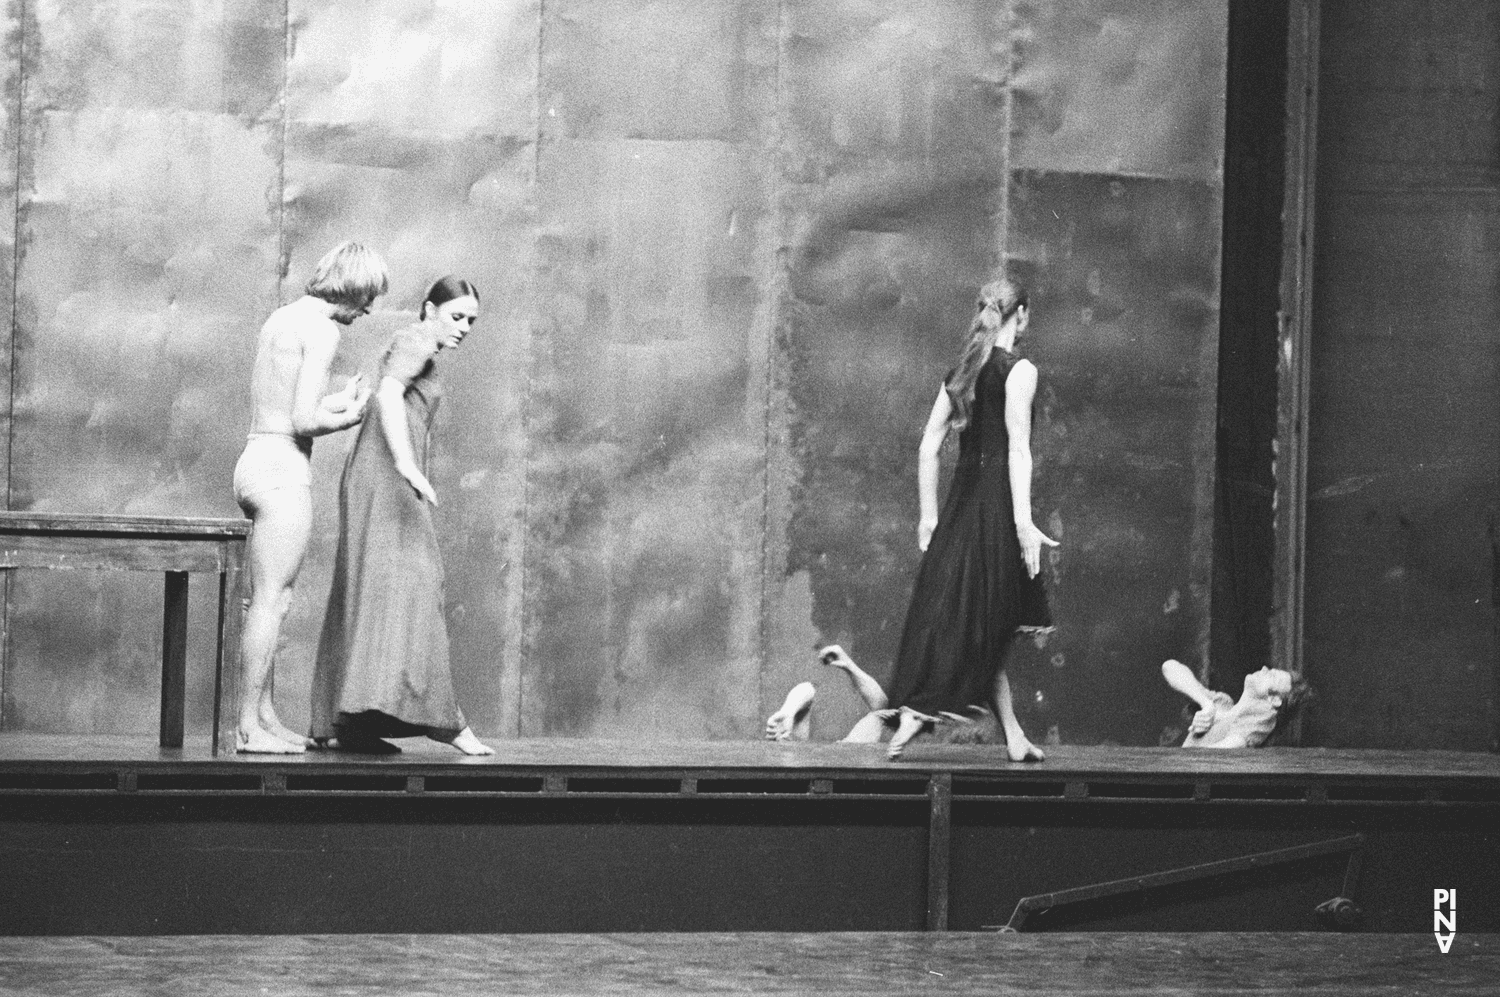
[0,511,251,754]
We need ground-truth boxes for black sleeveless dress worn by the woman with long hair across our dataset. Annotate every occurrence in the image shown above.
[887,349,1052,717]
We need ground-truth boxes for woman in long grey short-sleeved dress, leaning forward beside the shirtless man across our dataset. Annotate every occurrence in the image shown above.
[312,277,492,754]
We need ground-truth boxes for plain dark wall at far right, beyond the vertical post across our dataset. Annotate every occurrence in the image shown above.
[1305,0,1500,750]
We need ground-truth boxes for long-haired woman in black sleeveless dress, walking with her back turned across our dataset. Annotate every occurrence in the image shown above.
[887,279,1058,762]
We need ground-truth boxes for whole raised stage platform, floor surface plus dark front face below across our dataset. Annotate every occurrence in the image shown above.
[0,735,1500,936]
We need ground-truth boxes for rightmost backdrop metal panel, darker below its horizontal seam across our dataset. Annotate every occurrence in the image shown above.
[1008,0,1227,744]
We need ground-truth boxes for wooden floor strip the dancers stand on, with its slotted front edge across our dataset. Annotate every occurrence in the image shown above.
[0,733,1500,805]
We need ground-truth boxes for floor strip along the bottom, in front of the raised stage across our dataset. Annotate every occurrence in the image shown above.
[0,934,1500,997]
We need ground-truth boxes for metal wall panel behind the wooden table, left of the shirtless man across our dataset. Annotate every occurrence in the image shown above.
[5,1,285,733]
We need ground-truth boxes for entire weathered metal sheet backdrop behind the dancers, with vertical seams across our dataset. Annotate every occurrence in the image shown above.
[5,0,1226,744]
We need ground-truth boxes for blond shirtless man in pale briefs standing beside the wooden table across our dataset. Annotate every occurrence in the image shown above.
[234,243,390,754]
